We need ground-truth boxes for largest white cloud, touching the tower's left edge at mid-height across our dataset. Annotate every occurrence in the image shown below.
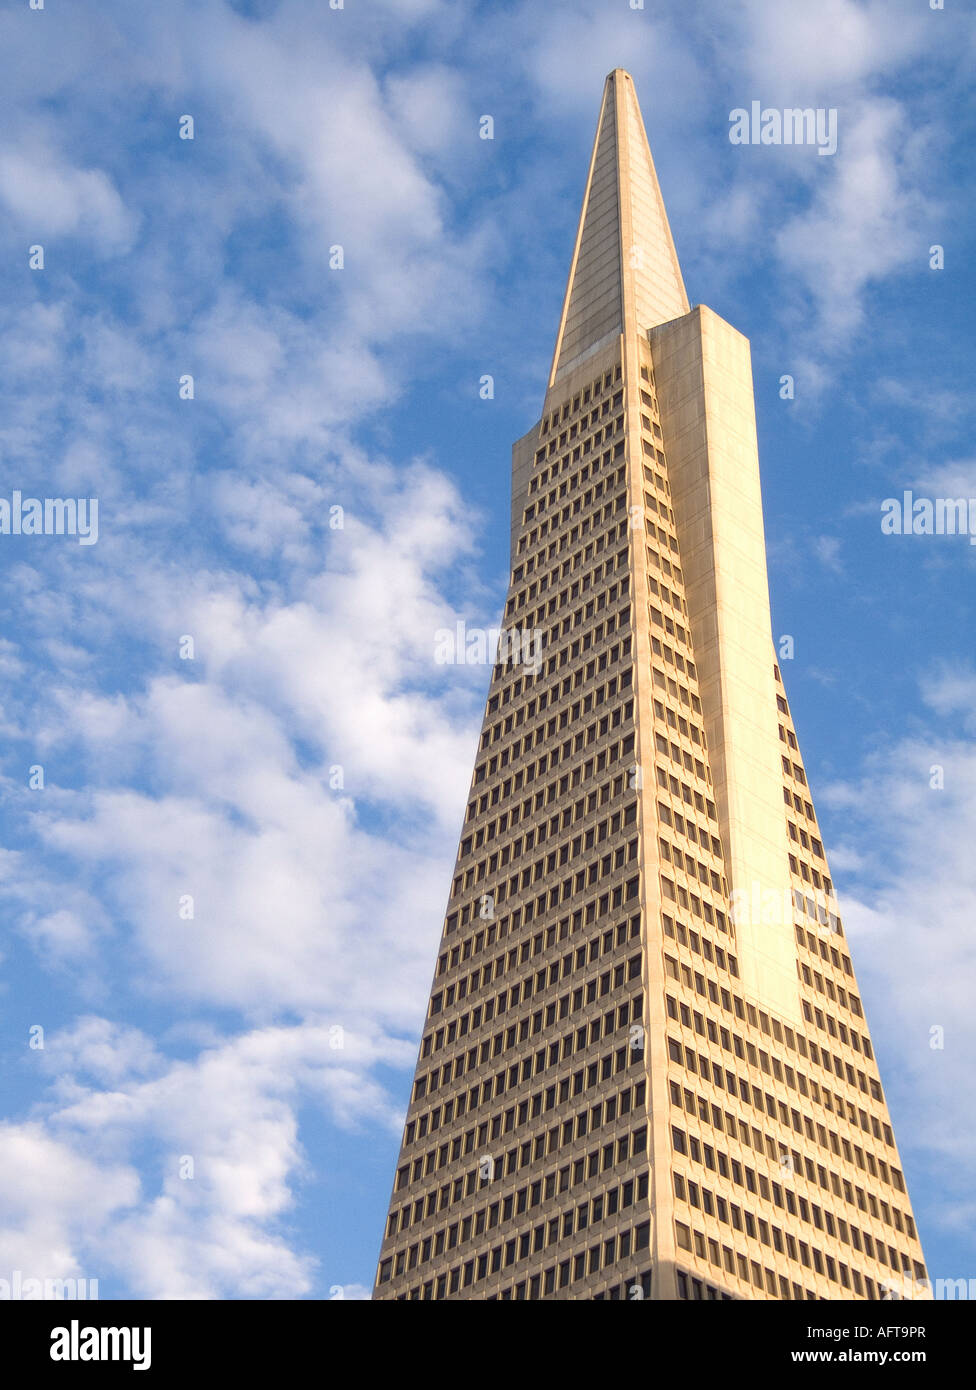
[0,444,496,1027]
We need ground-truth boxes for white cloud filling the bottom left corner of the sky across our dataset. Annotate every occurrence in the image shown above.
[0,1016,396,1298]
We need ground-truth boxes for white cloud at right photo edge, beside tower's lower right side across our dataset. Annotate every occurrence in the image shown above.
[829,695,976,1236]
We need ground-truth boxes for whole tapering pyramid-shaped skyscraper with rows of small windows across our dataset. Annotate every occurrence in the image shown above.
[374,70,925,1300]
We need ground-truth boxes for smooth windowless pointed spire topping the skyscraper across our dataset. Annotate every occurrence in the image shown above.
[549,68,690,385]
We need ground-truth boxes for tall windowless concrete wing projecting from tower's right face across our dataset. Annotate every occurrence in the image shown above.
[651,306,802,1027]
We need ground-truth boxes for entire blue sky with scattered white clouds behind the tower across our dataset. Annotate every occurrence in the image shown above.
[0,0,976,1298]
